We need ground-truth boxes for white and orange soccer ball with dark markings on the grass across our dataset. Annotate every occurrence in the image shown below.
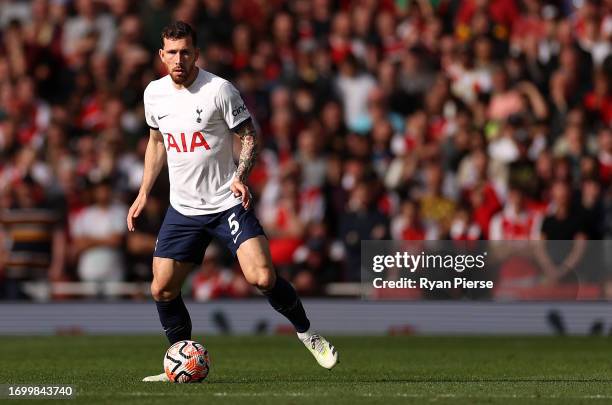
[164,340,210,383]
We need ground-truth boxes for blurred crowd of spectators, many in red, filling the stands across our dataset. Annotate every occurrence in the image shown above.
[0,0,612,299]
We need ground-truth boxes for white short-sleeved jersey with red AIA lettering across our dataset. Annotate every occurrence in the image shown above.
[144,69,250,215]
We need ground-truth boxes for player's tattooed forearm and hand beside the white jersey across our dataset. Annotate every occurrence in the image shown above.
[230,119,259,209]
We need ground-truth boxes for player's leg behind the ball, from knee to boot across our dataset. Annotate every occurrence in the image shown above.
[143,257,193,382]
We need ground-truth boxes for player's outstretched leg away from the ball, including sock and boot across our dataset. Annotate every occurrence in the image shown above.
[237,235,338,369]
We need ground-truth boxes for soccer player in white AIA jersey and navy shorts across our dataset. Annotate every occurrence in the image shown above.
[127,21,338,381]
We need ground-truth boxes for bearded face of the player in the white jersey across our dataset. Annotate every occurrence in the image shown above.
[159,37,199,84]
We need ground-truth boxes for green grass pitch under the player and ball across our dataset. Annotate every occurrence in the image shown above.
[0,336,612,405]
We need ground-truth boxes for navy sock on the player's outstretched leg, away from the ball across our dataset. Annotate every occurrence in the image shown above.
[262,277,310,333]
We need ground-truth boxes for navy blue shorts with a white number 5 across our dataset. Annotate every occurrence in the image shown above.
[153,204,265,264]
